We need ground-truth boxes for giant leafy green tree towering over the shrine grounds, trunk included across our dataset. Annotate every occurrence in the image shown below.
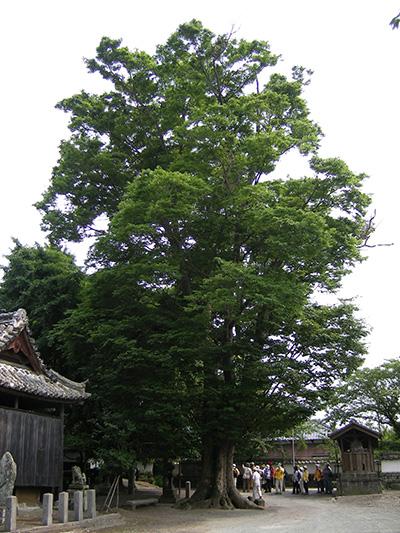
[38,21,371,508]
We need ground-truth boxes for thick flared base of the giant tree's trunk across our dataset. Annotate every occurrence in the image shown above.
[178,438,263,509]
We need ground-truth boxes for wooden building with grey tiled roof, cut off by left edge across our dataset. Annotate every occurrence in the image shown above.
[0,309,90,501]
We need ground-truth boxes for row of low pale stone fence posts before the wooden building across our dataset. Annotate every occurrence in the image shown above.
[4,490,96,532]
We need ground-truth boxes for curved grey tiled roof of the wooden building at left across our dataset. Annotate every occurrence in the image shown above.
[0,309,90,402]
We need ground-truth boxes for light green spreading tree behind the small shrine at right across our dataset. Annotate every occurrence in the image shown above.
[327,358,400,440]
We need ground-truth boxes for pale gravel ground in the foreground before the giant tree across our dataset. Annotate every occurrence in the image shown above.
[99,491,400,533]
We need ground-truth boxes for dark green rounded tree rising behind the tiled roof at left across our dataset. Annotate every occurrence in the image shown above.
[0,240,84,371]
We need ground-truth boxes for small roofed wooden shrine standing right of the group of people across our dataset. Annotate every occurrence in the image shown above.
[329,420,381,494]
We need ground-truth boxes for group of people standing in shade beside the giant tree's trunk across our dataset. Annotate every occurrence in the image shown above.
[232,461,333,500]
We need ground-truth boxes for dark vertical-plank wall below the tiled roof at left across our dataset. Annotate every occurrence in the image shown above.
[0,407,63,488]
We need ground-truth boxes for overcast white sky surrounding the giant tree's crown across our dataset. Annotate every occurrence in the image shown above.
[0,0,400,366]
